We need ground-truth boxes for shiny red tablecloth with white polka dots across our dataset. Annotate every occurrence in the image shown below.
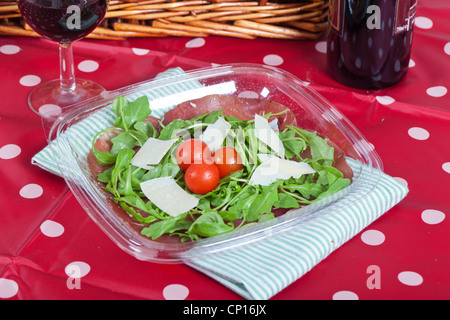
[0,0,450,300]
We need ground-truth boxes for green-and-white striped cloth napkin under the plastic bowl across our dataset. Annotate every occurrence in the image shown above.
[32,68,408,300]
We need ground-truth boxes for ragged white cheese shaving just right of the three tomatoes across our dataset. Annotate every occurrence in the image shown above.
[249,154,316,186]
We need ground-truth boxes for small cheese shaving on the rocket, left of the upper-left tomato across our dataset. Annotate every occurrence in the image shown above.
[131,138,178,170]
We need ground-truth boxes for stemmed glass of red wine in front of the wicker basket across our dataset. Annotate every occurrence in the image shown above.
[18,0,109,118]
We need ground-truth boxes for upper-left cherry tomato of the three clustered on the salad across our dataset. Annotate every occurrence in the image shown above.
[175,139,212,172]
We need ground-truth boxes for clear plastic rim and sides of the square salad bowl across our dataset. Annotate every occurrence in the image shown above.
[49,64,382,263]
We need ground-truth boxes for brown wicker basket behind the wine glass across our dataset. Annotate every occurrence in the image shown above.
[0,0,328,40]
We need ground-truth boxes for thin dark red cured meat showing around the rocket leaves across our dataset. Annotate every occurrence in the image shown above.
[87,95,353,242]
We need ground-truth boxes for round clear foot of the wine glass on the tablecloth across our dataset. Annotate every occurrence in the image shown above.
[28,79,106,118]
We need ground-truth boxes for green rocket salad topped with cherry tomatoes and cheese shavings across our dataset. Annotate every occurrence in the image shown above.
[92,97,351,241]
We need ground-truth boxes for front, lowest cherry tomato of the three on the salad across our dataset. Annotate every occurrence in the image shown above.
[184,163,220,194]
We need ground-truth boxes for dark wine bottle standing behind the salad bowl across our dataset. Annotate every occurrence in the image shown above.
[327,0,417,89]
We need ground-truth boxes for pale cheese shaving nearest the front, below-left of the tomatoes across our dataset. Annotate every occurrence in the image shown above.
[140,177,198,217]
